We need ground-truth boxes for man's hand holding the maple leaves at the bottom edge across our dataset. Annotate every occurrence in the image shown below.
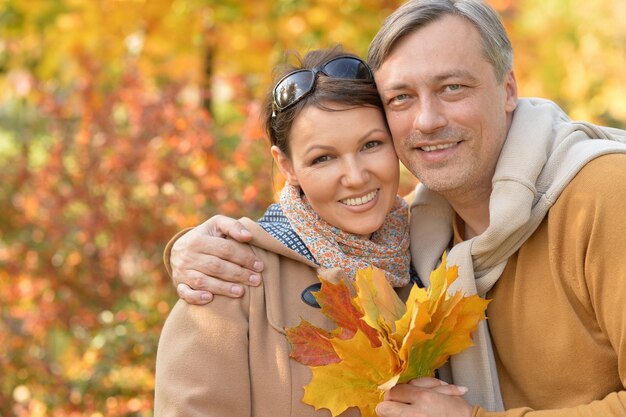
[376,378,474,417]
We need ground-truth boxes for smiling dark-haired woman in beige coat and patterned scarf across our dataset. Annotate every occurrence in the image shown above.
[155,49,410,417]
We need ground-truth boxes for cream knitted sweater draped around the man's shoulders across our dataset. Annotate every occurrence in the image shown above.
[411,99,626,411]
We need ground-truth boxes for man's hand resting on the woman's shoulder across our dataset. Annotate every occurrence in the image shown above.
[170,215,263,304]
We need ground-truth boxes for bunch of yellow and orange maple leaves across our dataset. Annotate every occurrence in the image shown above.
[287,255,489,417]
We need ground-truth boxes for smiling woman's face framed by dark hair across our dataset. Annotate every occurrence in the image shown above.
[272,104,400,237]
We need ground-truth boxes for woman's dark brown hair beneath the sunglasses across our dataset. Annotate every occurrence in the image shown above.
[262,47,384,156]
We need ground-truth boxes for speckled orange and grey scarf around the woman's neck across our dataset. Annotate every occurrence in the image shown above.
[280,184,410,287]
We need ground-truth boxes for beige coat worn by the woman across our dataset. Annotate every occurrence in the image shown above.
[154,218,360,417]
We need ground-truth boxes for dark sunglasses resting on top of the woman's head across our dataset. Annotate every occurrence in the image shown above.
[272,56,374,116]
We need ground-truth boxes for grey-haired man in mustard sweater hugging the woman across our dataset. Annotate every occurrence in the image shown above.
[166,0,626,417]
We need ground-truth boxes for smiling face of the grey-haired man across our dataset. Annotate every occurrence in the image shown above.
[376,16,517,200]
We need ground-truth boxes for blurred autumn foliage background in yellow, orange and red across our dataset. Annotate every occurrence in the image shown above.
[0,0,626,417]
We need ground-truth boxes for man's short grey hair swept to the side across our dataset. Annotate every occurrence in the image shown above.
[368,0,513,82]
